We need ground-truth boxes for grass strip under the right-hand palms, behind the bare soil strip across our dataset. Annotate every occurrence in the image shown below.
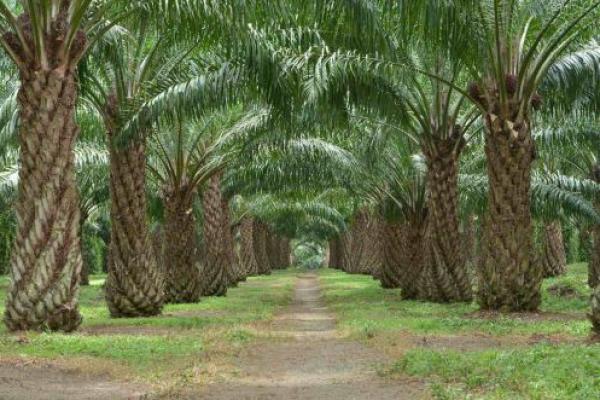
[320,264,590,337]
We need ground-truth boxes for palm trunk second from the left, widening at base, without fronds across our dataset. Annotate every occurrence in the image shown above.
[106,138,165,317]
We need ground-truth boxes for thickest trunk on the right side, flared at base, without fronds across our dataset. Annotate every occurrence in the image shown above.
[478,115,543,311]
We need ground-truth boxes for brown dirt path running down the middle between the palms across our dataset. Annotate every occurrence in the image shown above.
[188,274,426,400]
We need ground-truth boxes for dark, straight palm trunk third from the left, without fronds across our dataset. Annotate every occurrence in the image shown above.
[162,186,202,303]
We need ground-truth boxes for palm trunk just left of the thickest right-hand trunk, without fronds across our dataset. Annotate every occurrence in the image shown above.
[424,142,473,302]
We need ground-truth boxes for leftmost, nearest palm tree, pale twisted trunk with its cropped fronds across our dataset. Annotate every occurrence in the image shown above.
[0,0,133,331]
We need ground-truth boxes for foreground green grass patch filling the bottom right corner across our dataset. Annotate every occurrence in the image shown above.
[388,344,600,400]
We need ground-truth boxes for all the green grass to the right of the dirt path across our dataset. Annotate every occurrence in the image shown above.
[321,264,600,400]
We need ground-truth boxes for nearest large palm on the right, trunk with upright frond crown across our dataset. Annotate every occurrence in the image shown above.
[404,0,600,311]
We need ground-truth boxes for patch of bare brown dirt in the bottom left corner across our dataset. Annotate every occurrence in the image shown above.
[0,359,145,400]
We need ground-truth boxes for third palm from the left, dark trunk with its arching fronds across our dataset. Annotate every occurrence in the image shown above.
[148,107,269,303]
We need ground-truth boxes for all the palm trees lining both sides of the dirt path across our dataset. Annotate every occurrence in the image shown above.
[0,0,600,330]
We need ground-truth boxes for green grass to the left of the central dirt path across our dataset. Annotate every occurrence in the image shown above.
[0,270,295,379]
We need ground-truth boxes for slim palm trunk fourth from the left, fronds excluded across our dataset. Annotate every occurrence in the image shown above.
[202,175,230,296]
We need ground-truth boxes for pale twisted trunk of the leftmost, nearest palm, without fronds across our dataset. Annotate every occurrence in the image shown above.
[4,66,82,331]
